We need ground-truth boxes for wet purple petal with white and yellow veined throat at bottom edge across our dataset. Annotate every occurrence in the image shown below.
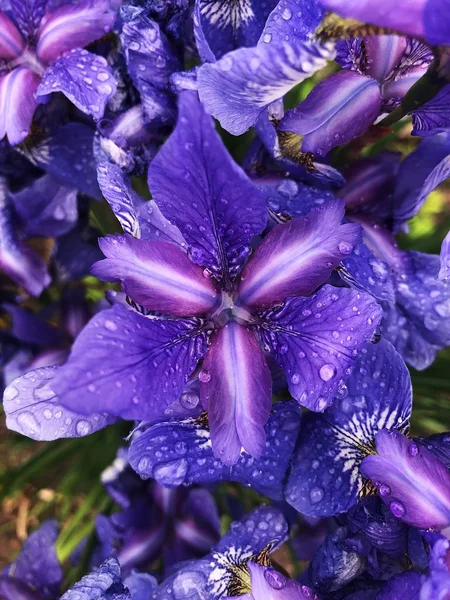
[154,506,287,600]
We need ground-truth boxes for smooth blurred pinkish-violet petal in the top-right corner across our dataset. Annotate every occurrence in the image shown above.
[320,0,450,45]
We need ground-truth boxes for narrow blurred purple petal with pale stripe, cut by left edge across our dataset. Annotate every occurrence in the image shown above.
[0,195,51,296]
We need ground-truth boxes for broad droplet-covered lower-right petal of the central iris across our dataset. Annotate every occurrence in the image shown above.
[260,285,381,412]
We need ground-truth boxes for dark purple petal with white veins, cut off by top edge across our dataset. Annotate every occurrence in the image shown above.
[194,0,277,61]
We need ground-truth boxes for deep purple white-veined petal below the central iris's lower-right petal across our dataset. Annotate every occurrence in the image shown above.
[286,340,412,517]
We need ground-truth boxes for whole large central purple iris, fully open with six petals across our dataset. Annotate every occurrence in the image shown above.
[48,92,380,464]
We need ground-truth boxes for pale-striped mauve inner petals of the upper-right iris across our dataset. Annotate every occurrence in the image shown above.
[278,35,433,156]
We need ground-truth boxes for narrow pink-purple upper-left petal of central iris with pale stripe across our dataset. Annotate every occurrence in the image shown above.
[91,235,218,317]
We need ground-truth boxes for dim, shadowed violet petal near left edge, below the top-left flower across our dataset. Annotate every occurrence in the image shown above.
[12,175,78,237]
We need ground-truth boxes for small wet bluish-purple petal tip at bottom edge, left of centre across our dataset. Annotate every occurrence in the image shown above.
[60,557,132,600]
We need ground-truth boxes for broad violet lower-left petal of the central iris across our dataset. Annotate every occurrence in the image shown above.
[52,305,206,420]
